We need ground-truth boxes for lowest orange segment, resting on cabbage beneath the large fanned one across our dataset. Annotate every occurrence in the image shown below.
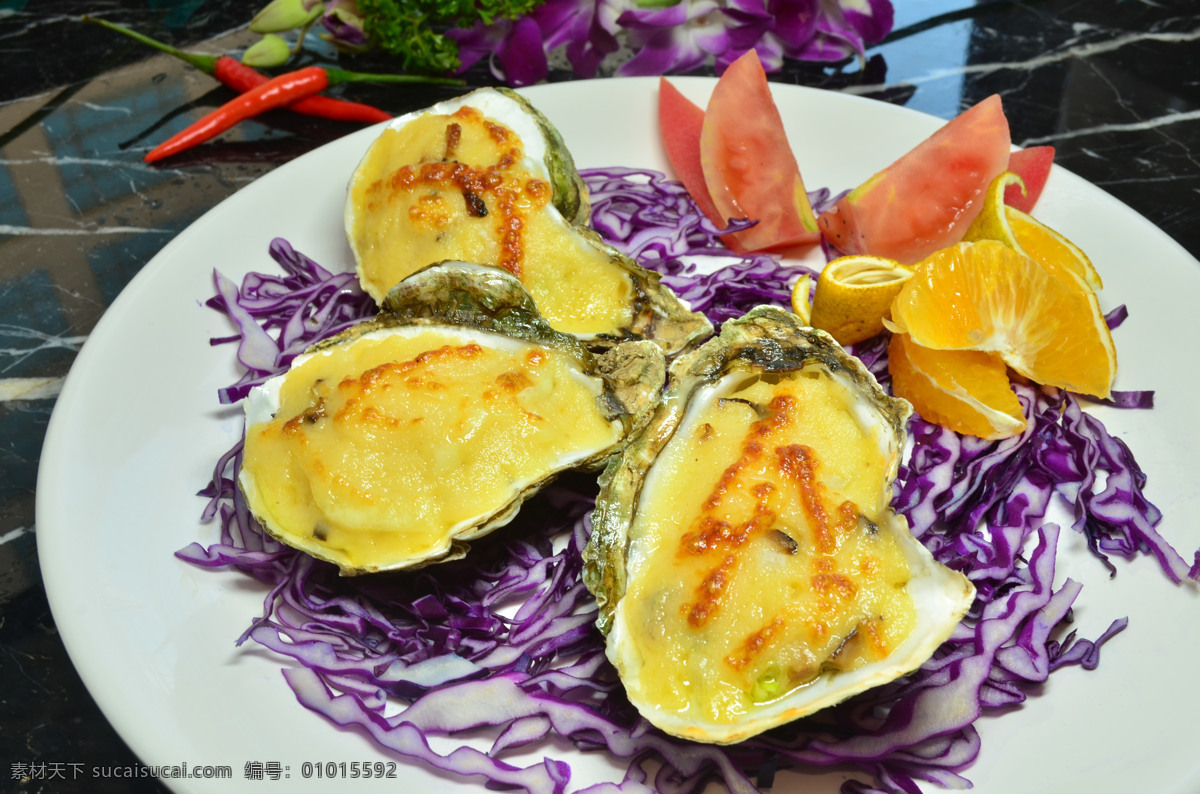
[888,333,1026,439]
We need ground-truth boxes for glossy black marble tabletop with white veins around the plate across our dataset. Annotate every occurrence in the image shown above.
[0,0,1200,793]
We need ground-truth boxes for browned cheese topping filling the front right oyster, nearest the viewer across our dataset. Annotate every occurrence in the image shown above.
[622,369,916,723]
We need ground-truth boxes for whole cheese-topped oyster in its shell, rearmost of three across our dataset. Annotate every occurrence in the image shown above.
[346,89,713,355]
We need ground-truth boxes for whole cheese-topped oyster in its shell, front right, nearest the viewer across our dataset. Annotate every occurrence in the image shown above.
[584,307,974,744]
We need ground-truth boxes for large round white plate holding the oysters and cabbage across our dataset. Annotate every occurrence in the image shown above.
[37,79,1200,794]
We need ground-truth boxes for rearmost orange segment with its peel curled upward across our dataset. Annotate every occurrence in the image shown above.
[962,172,1104,289]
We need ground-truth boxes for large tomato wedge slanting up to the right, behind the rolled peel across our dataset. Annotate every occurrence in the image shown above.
[817,95,1012,265]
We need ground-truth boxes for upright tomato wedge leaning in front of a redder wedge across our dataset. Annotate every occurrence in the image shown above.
[700,49,821,252]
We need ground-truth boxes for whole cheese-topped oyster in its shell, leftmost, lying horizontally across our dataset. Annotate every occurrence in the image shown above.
[239,263,666,573]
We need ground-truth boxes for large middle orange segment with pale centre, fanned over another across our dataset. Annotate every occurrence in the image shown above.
[889,240,1117,397]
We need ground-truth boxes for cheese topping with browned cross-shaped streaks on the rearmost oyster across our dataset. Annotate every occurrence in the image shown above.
[349,107,634,335]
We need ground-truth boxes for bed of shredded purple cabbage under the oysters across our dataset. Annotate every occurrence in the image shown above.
[178,169,1200,794]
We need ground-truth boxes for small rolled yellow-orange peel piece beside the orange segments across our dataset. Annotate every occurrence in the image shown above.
[810,254,912,344]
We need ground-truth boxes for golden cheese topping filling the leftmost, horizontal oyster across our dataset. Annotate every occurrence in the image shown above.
[241,329,622,570]
